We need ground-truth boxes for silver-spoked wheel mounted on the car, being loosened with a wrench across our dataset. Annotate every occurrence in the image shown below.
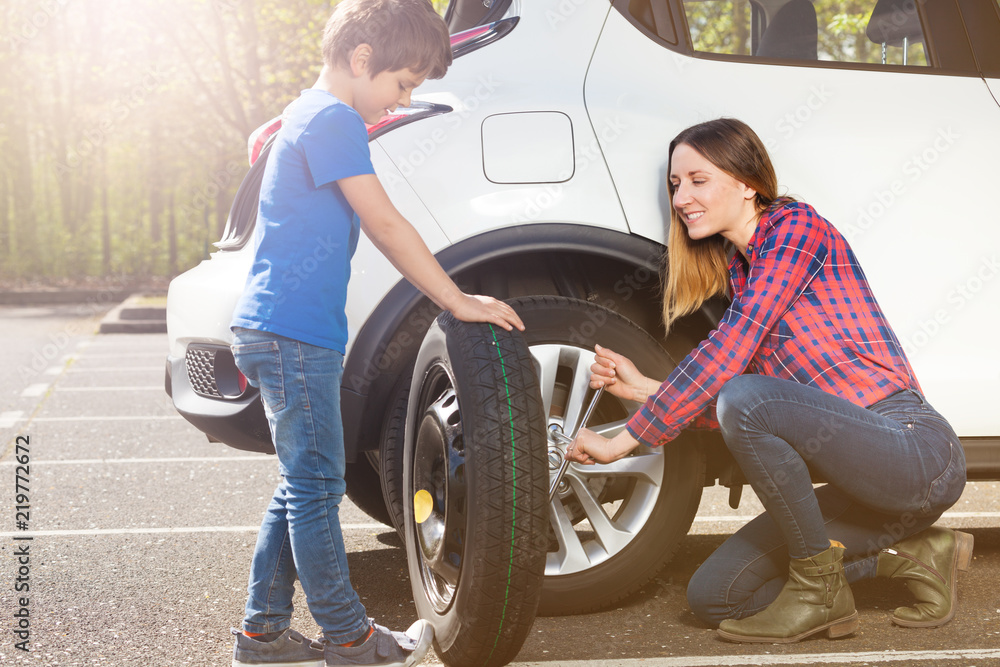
[509,296,705,615]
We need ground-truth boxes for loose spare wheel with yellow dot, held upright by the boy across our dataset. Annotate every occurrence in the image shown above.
[403,313,548,665]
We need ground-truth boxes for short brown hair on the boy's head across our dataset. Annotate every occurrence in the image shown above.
[323,0,451,79]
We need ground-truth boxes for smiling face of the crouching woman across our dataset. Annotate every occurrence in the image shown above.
[670,144,757,247]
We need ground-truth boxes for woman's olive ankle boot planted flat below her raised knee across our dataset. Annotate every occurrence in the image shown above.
[718,542,858,644]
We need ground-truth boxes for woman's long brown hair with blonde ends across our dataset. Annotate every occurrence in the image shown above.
[662,118,791,331]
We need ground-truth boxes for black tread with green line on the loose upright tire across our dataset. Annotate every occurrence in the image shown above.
[439,313,548,667]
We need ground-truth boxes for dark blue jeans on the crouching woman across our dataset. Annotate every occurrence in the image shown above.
[688,375,965,627]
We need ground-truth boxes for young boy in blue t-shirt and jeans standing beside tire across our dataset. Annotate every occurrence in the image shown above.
[232,0,524,667]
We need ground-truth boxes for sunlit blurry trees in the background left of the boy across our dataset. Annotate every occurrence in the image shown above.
[0,0,360,282]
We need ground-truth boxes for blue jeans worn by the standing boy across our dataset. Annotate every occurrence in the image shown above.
[233,329,368,643]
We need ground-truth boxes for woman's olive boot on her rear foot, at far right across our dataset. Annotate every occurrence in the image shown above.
[877,526,973,628]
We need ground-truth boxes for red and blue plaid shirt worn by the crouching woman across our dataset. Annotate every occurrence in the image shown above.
[628,202,920,446]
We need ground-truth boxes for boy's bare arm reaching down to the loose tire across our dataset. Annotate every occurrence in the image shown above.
[337,174,524,331]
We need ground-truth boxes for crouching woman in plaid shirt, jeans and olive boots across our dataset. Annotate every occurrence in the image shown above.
[567,118,972,643]
